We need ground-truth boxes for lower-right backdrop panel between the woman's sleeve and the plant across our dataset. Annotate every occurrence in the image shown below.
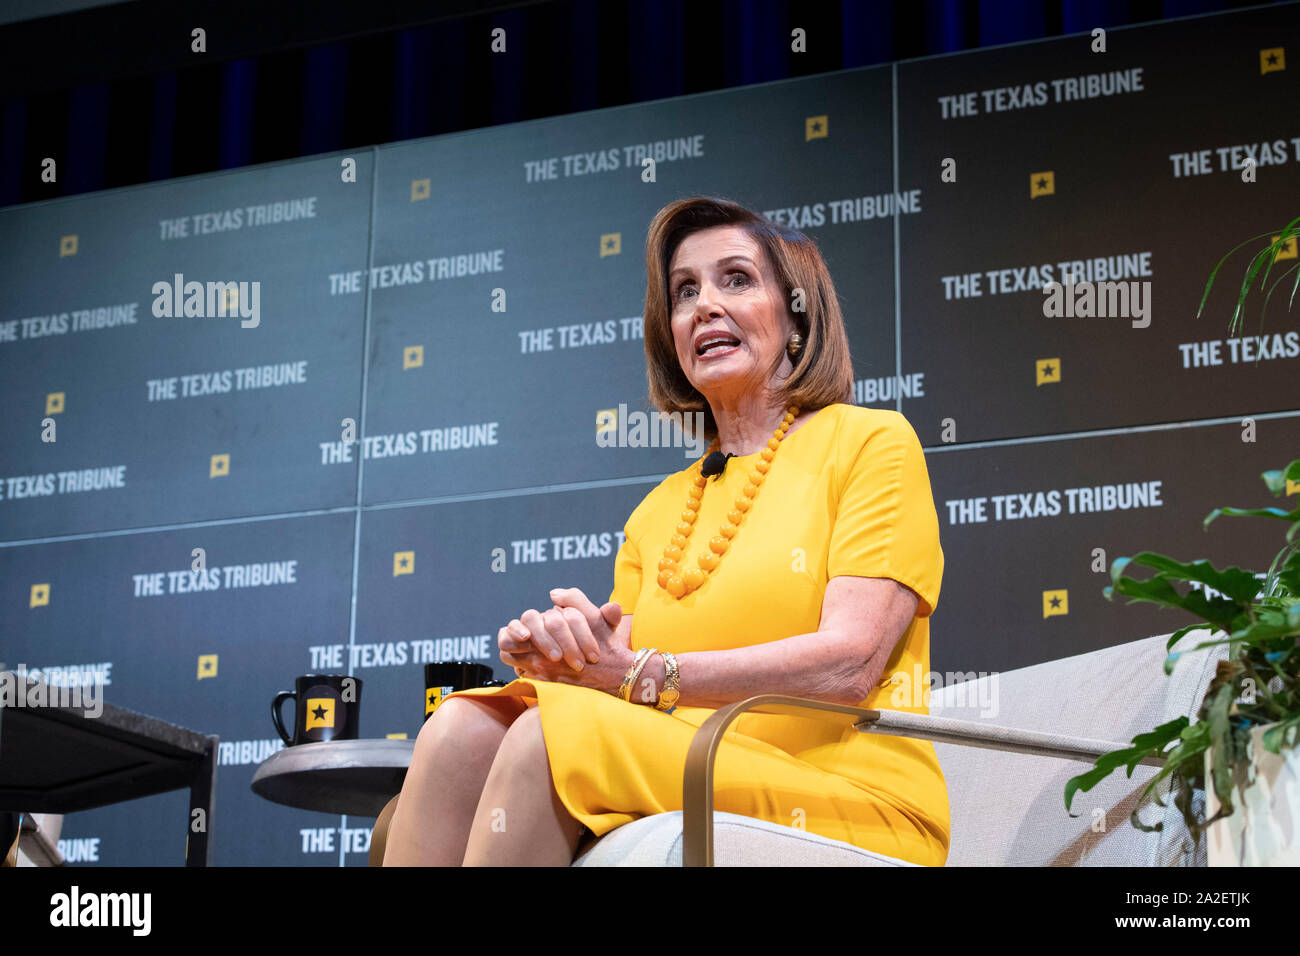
[926,418,1300,679]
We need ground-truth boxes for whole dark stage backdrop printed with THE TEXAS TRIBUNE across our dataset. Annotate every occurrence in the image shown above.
[0,7,1300,865]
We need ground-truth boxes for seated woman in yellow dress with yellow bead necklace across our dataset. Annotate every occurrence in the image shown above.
[384,198,949,866]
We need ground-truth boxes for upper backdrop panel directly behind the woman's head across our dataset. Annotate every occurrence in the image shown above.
[358,69,894,503]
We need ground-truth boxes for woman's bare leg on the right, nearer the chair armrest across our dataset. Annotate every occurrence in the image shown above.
[464,708,582,866]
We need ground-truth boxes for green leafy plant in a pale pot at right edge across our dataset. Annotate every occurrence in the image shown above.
[1065,217,1300,865]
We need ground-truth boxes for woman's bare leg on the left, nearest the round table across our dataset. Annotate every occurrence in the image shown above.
[384,697,525,866]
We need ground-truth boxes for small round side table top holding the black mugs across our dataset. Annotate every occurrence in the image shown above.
[251,739,415,817]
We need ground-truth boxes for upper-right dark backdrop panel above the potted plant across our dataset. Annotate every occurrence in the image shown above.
[898,5,1300,445]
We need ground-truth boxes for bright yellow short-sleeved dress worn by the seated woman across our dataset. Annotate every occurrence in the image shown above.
[444,405,949,866]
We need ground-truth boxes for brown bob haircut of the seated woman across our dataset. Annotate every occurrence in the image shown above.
[645,196,853,440]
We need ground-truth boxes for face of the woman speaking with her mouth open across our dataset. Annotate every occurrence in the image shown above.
[668,226,794,407]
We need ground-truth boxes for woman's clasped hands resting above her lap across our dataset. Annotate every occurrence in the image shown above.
[497,588,634,693]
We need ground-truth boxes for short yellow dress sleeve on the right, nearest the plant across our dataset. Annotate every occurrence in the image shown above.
[827,414,944,618]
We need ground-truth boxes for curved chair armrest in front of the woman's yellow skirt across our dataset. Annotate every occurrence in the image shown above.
[681,693,1165,866]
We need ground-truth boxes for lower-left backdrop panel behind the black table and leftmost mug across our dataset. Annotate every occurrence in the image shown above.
[0,512,356,865]
